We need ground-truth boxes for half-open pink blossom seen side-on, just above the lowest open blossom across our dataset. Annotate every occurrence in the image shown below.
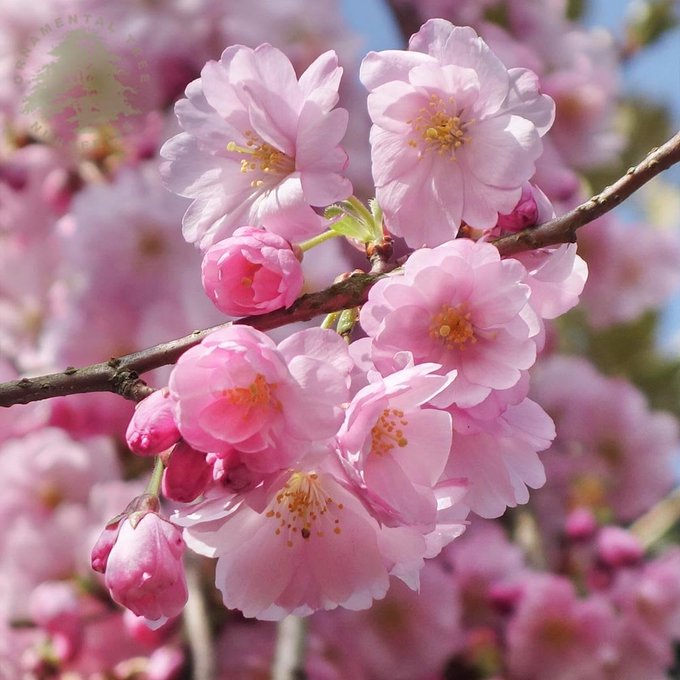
[338,364,460,532]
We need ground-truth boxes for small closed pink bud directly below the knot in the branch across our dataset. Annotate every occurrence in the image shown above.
[125,388,180,456]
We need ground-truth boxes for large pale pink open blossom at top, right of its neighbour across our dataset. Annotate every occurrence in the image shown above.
[361,19,554,247]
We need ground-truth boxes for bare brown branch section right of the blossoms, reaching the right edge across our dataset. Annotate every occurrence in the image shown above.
[493,132,680,255]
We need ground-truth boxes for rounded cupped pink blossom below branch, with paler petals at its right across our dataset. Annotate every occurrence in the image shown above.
[170,326,352,472]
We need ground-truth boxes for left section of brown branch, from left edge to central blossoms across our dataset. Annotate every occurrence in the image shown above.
[0,273,384,407]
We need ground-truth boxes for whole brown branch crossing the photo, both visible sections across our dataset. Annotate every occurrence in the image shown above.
[0,132,680,407]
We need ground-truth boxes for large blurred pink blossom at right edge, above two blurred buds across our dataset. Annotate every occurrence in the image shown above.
[532,356,678,524]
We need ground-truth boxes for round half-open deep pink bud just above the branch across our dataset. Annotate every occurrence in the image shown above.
[202,227,303,316]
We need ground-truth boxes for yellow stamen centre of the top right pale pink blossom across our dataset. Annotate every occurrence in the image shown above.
[406,94,473,160]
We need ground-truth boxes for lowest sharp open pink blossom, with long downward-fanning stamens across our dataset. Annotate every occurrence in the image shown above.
[175,470,389,620]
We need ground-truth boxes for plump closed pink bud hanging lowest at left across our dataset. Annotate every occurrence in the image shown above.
[100,512,187,623]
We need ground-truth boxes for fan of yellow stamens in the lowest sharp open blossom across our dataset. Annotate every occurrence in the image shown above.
[265,472,344,548]
